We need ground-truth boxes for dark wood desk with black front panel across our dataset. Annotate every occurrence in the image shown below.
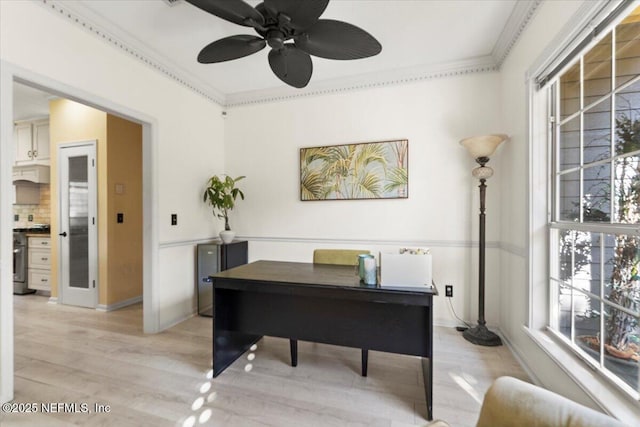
[211,261,438,420]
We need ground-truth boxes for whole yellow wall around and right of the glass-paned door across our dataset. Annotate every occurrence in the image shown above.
[49,99,142,305]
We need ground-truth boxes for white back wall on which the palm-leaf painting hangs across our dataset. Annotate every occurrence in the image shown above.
[225,73,501,324]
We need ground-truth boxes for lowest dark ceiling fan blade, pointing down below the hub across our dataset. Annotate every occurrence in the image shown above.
[269,44,313,88]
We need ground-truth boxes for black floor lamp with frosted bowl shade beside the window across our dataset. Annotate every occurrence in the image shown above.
[460,134,507,346]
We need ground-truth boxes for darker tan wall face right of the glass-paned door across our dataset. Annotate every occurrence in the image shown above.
[106,114,142,304]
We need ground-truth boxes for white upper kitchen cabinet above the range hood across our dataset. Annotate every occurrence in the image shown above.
[13,120,50,165]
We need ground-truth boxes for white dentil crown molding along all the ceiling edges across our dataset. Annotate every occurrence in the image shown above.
[38,0,544,108]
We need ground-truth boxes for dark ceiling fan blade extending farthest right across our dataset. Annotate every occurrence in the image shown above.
[295,19,382,59]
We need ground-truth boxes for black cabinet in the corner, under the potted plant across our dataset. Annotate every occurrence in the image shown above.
[196,240,248,317]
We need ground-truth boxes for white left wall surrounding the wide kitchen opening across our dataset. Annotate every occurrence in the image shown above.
[0,1,224,401]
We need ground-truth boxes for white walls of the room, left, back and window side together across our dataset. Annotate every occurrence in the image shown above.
[0,1,632,422]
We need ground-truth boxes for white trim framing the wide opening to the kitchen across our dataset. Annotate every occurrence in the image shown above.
[0,59,160,403]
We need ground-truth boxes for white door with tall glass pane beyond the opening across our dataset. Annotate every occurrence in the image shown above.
[58,141,98,308]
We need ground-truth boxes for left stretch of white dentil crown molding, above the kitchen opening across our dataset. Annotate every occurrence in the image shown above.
[39,0,225,106]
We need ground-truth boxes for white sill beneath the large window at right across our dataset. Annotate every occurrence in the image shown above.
[523,326,640,425]
